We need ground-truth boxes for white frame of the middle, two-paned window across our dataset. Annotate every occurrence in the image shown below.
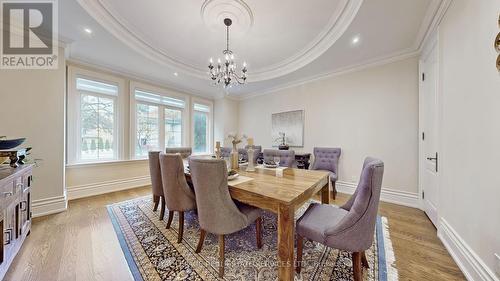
[129,81,190,159]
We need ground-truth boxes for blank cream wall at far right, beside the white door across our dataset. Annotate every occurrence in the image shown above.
[439,0,500,280]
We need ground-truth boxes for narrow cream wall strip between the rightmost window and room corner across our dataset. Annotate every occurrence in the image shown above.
[214,98,239,147]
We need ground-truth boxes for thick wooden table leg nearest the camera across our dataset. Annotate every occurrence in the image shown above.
[278,205,295,281]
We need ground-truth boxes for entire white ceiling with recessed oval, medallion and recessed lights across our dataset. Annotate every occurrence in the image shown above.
[59,0,442,98]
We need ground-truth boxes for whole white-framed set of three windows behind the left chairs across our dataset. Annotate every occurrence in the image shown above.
[66,65,213,163]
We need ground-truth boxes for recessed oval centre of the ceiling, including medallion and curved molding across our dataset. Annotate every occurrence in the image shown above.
[75,0,362,82]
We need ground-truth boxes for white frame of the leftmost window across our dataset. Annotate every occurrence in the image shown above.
[66,65,125,165]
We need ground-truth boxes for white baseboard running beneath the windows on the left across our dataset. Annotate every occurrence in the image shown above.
[66,175,151,200]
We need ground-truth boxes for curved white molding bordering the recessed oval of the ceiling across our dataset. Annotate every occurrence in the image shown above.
[78,0,363,82]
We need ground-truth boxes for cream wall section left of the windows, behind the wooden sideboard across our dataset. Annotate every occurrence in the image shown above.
[0,49,66,215]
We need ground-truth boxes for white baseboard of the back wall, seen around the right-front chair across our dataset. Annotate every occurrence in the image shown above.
[335,181,420,208]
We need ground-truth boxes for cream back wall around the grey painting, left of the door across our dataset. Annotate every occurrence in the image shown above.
[239,58,418,195]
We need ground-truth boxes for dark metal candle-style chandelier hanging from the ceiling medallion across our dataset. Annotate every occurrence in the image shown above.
[208,18,247,88]
